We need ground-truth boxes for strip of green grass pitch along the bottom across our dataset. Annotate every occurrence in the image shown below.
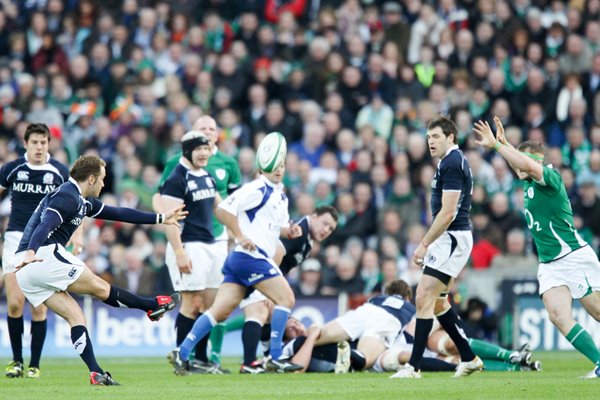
[0,352,600,400]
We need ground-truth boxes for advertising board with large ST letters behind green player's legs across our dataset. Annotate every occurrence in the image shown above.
[515,296,600,350]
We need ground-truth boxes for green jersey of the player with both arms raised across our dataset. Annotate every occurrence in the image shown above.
[523,166,587,263]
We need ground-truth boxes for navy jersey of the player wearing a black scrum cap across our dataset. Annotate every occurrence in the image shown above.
[160,163,217,243]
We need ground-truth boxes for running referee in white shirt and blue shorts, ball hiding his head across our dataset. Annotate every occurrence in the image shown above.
[172,133,302,375]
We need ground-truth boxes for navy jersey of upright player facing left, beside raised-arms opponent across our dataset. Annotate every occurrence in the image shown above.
[431,145,473,231]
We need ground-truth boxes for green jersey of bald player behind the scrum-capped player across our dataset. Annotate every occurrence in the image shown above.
[160,149,242,238]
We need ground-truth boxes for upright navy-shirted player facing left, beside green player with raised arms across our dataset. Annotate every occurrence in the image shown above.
[393,117,483,378]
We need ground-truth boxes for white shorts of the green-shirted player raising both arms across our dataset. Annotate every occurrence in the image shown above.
[538,246,600,299]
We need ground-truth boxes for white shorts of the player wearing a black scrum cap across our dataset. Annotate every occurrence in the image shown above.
[165,241,227,292]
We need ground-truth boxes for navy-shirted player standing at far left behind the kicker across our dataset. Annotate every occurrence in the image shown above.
[0,124,75,378]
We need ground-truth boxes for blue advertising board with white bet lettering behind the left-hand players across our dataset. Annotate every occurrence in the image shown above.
[0,297,338,359]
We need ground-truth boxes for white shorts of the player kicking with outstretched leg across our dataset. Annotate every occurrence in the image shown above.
[15,244,86,307]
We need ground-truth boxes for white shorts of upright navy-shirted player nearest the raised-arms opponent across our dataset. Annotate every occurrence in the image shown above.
[424,231,473,278]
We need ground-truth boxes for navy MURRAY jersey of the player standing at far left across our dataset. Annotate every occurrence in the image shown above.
[0,156,69,232]
